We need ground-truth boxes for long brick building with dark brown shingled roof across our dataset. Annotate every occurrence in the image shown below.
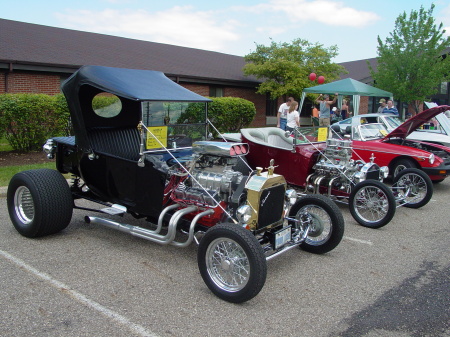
[0,19,450,126]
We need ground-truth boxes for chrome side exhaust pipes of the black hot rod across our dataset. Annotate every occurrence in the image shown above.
[85,205,214,247]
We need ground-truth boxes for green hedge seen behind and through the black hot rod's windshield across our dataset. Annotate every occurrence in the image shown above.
[179,97,256,136]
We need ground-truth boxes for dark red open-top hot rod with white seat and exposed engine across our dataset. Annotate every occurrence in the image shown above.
[223,127,433,228]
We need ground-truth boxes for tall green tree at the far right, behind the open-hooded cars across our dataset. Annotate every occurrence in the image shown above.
[369,4,450,113]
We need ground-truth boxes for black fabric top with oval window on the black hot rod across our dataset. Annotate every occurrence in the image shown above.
[61,66,211,150]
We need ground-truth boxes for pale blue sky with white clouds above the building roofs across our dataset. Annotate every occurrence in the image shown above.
[0,0,450,63]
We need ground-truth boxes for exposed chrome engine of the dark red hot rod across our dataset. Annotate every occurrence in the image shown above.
[305,139,388,196]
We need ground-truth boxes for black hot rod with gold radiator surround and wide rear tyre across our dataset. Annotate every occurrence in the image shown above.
[7,66,344,303]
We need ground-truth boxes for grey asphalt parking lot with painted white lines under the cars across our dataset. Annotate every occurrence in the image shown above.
[0,178,450,337]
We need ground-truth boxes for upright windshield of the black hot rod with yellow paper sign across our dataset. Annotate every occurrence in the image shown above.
[142,101,207,151]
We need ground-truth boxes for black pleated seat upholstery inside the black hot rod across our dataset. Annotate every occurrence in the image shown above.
[88,127,140,161]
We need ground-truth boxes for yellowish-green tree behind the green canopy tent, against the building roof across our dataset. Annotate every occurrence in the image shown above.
[244,39,346,99]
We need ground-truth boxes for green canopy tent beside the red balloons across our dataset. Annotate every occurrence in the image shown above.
[299,78,393,116]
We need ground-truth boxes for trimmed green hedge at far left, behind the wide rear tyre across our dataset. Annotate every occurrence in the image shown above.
[0,94,69,152]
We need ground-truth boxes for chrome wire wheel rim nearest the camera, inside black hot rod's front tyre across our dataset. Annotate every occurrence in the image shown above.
[205,238,250,292]
